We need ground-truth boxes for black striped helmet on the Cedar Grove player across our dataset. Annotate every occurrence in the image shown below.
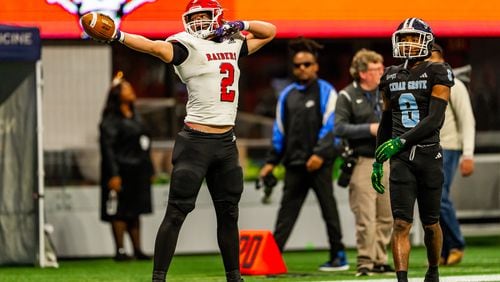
[392,18,434,60]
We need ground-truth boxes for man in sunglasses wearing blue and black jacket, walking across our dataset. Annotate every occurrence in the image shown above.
[260,37,349,271]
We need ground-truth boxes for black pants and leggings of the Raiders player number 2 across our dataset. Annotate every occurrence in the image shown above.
[154,127,243,278]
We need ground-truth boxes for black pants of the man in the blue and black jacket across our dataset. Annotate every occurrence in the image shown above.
[274,165,344,259]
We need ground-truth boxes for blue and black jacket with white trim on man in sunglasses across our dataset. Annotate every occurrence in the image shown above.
[267,79,337,166]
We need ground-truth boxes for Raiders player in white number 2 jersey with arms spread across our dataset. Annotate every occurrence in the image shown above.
[98,0,276,281]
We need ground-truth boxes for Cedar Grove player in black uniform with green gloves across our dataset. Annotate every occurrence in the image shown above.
[371,18,453,282]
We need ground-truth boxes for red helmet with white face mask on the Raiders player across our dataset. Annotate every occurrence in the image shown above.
[182,0,223,39]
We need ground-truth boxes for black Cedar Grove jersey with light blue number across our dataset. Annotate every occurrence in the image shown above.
[379,62,454,144]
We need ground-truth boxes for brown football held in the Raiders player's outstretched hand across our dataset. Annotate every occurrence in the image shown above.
[80,12,115,41]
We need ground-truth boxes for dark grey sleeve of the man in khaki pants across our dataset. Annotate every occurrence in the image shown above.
[334,90,371,139]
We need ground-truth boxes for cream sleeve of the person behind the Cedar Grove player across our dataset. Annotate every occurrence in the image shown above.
[450,80,476,157]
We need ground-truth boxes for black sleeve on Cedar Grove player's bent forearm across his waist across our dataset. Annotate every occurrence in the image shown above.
[400,96,448,146]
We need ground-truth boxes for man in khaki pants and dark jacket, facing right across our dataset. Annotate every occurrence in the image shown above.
[335,49,394,276]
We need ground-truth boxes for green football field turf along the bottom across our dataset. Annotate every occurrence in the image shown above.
[0,236,500,282]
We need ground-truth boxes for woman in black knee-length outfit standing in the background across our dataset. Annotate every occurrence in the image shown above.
[99,72,153,261]
